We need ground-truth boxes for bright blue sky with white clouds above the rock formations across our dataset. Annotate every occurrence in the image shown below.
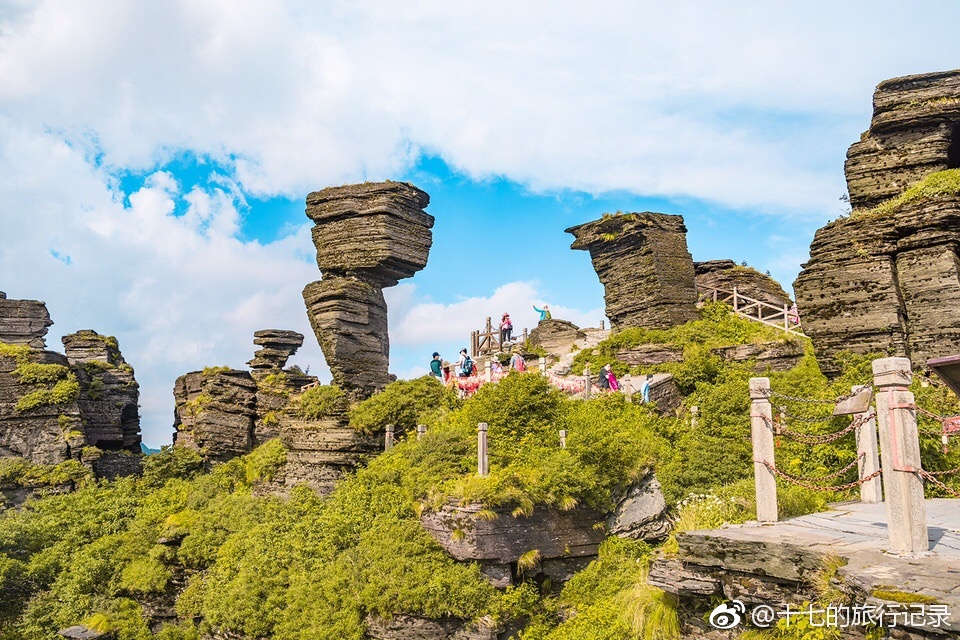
[0,0,960,446]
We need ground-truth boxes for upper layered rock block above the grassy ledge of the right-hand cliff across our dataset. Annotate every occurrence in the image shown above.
[844,70,960,209]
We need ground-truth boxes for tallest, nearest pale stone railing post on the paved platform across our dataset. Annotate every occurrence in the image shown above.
[873,358,930,553]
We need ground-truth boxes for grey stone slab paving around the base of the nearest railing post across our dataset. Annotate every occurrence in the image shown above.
[697,498,960,637]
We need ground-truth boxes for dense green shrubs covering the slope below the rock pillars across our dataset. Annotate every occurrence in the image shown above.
[0,305,960,640]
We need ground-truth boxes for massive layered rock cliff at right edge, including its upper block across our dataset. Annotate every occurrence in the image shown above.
[794,72,960,375]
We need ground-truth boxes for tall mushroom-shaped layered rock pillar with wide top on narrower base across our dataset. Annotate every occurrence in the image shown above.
[303,182,434,399]
